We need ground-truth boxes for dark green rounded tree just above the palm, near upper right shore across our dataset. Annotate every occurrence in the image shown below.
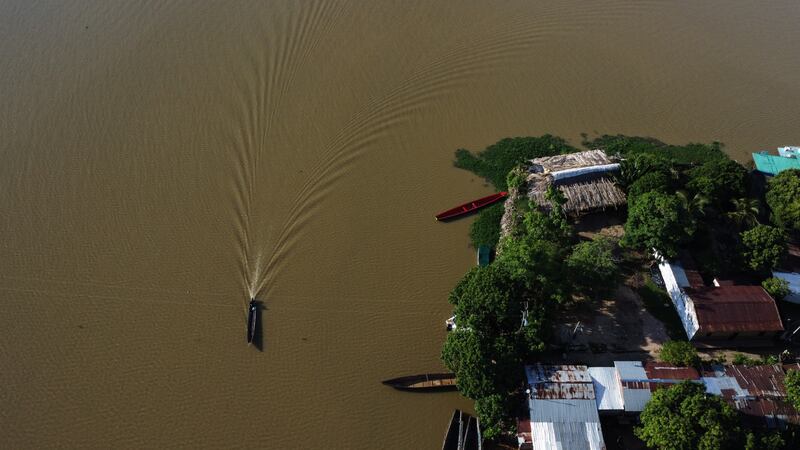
[686,158,747,209]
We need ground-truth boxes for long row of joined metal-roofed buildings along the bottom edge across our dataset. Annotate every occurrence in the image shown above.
[517,361,800,450]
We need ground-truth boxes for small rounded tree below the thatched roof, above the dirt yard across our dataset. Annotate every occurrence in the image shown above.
[567,236,619,295]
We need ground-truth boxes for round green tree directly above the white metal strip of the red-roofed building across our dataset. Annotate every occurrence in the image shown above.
[622,192,695,258]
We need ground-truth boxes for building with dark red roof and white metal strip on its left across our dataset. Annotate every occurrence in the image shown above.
[656,255,783,347]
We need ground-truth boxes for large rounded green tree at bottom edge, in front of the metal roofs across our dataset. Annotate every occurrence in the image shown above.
[635,381,741,450]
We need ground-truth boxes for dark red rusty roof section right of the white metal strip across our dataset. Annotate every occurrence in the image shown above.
[685,286,783,334]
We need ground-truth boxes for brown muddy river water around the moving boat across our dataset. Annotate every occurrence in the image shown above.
[0,0,800,449]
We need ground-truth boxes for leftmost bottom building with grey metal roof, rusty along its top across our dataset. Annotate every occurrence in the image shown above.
[517,364,606,450]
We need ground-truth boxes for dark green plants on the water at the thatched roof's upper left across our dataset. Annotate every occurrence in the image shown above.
[455,134,578,190]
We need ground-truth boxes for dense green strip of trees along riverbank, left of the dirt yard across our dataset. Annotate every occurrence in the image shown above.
[442,195,574,438]
